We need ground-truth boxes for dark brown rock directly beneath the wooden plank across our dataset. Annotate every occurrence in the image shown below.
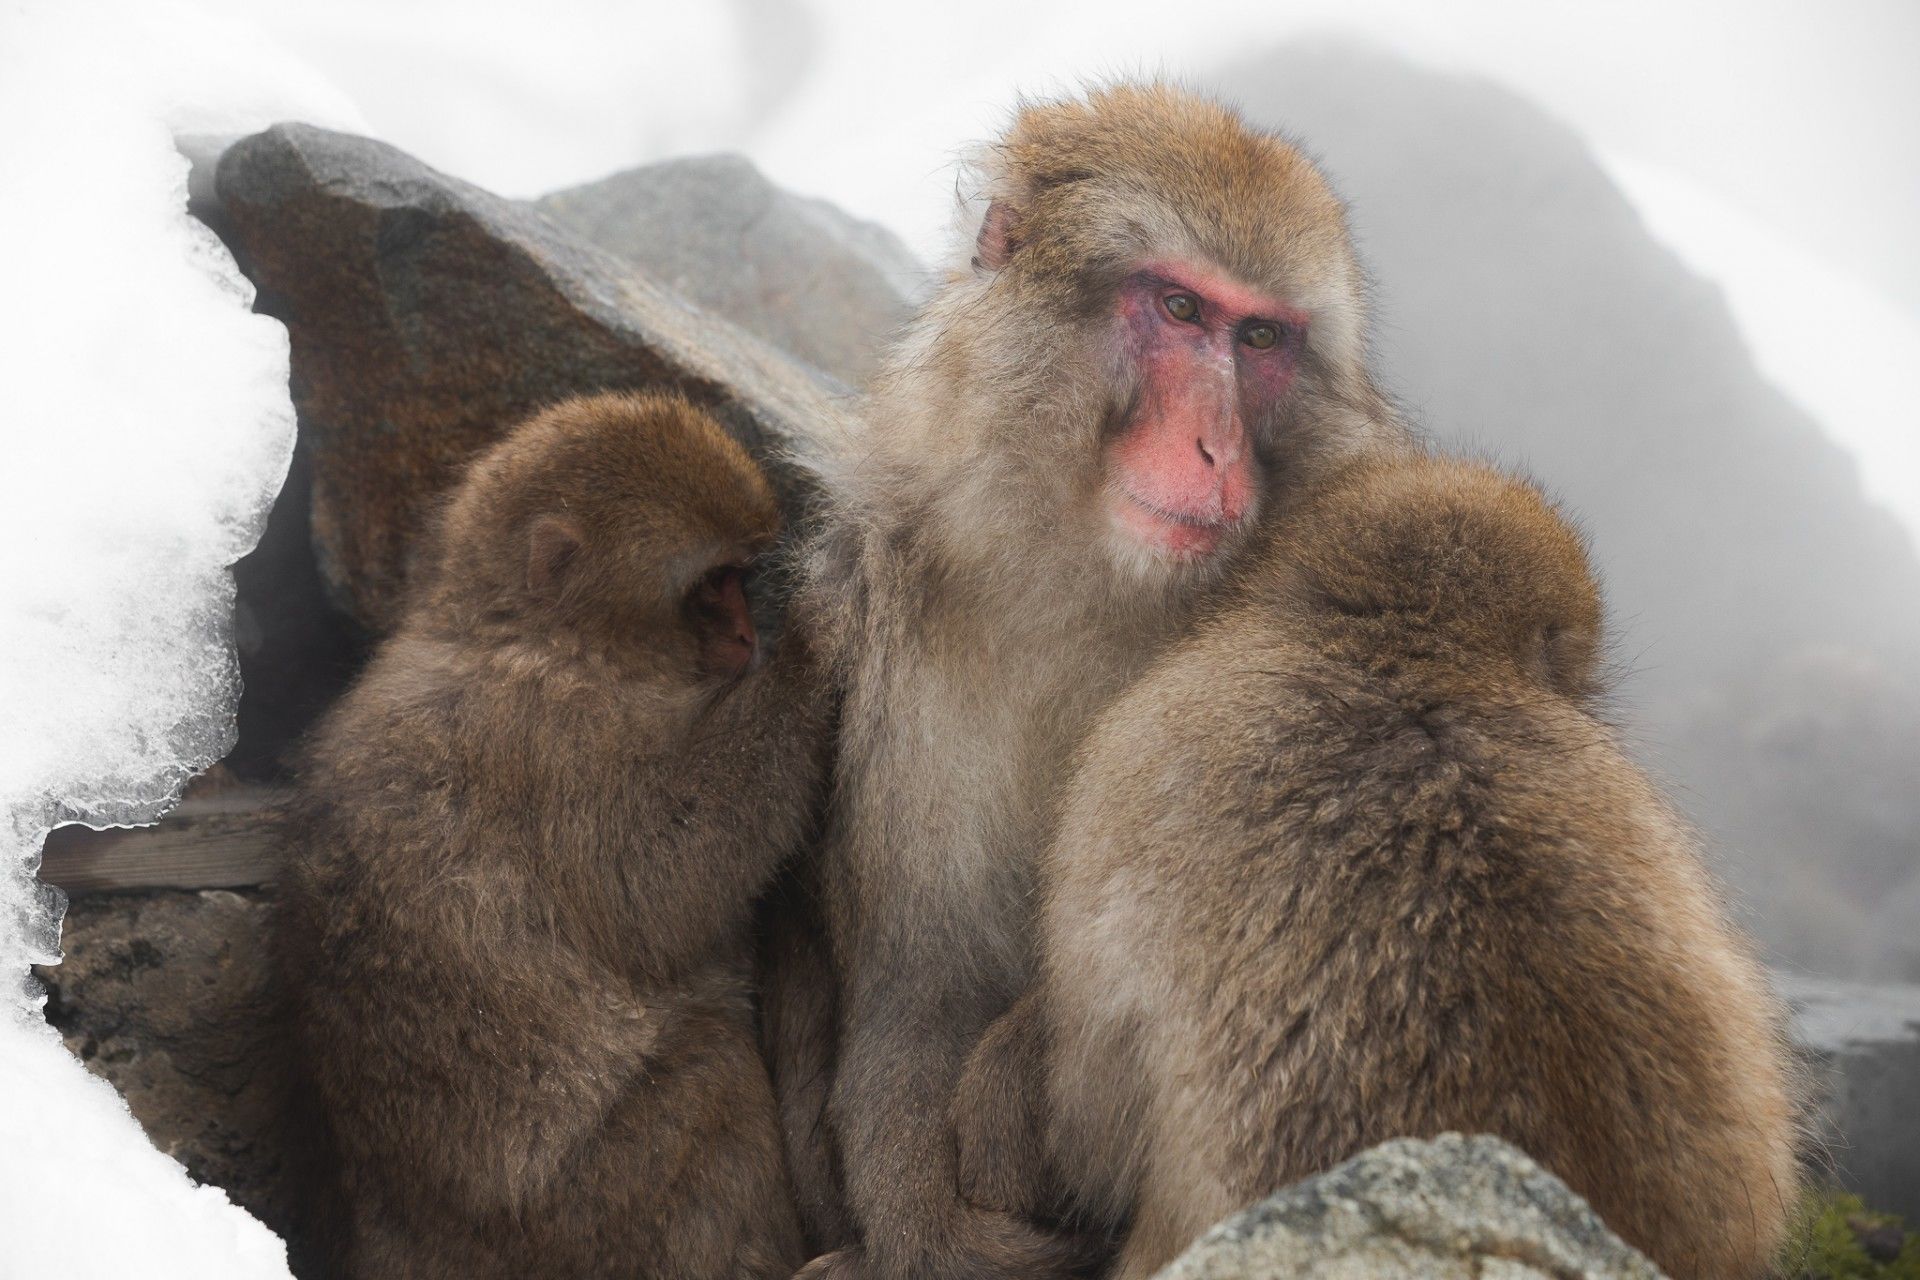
[33,889,288,1228]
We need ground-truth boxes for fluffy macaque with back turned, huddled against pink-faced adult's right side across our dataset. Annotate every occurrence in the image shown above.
[954,457,1797,1280]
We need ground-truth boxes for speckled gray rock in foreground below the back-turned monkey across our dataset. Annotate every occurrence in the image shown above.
[1160,1134,1661,1280]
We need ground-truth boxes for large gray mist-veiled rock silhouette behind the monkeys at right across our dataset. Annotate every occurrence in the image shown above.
[1210,46,1920,977]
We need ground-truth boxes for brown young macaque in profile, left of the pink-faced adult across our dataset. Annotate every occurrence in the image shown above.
[280,395,824,1278]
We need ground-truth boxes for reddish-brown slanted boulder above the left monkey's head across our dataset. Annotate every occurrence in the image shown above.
[215,125,845,631]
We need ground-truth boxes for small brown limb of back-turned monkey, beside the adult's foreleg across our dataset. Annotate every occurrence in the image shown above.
[952,983,1046,1217]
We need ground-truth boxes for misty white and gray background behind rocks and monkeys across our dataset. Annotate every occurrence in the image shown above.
[172,0,1920,981]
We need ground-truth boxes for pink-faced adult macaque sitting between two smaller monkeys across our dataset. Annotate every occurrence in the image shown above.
[787,86,1402,1280]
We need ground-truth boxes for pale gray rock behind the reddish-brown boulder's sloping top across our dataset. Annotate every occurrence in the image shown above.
[534,155,925,386]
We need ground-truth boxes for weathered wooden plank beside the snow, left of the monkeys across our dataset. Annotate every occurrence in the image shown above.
[40,787,286,894]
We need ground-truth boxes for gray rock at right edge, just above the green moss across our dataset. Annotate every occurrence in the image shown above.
[1774,973,1920,1222]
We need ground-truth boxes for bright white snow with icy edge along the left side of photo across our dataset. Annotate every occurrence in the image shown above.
[0,0,359,1280]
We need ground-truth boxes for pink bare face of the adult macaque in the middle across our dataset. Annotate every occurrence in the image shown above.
[1106,263,1308,560]
